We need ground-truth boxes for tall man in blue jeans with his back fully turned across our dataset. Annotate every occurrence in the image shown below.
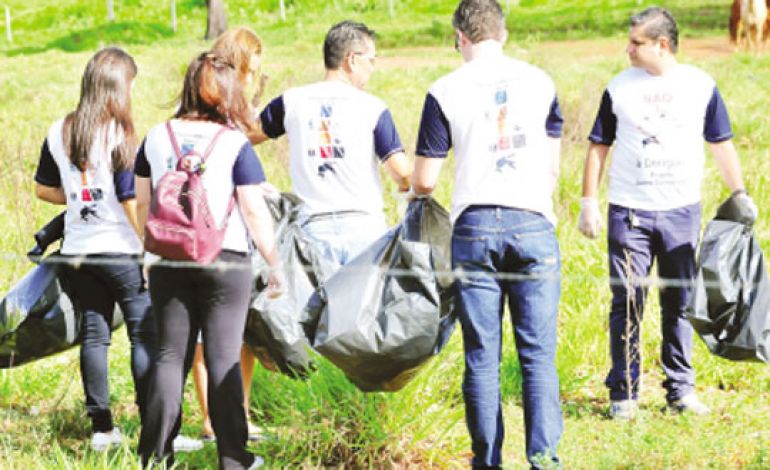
[413,0,563,468]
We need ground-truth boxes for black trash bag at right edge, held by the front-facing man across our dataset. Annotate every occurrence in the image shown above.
[688,197,770,362]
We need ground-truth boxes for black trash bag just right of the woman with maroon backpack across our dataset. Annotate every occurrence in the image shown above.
[244,194,333,378]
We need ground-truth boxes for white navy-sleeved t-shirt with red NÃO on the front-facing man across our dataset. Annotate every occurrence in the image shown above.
[589,64,732,210]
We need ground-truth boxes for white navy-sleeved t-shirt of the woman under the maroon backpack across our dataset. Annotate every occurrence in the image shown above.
[136,119,265,253]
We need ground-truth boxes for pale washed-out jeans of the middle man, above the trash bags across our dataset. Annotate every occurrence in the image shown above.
[302,211,388,268]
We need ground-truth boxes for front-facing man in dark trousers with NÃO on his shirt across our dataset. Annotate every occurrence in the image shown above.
[579,7,755,419]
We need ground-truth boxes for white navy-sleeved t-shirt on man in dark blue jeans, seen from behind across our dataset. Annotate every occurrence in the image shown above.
[417,53,562,225]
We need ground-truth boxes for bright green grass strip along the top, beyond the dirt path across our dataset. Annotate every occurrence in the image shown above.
[0,0,730,55]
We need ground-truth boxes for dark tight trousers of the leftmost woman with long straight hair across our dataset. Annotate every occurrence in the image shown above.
[72,254,155,432]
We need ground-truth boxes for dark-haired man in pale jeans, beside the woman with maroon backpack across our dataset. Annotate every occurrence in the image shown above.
[256,21,412,265]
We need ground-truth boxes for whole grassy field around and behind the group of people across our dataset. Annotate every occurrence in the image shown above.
[0,0,770,469]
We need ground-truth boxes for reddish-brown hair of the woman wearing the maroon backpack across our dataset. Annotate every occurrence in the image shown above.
[174,52,254,133]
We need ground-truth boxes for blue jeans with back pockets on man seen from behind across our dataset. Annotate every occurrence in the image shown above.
[452,206,563,468]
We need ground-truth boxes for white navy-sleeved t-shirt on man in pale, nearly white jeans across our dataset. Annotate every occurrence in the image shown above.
[260,81,403,215]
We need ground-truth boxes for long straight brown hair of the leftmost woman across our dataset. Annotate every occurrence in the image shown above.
[63,47,137,171]
